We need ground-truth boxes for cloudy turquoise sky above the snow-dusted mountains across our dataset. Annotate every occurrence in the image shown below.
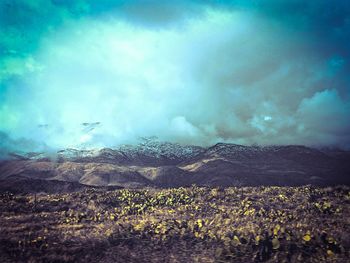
[0,0,350,155]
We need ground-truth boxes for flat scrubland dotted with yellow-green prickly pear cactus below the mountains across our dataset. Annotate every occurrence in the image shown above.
[0,186,350,262]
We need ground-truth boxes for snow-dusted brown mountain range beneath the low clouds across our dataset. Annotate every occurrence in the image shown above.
[0,139,350,193]
